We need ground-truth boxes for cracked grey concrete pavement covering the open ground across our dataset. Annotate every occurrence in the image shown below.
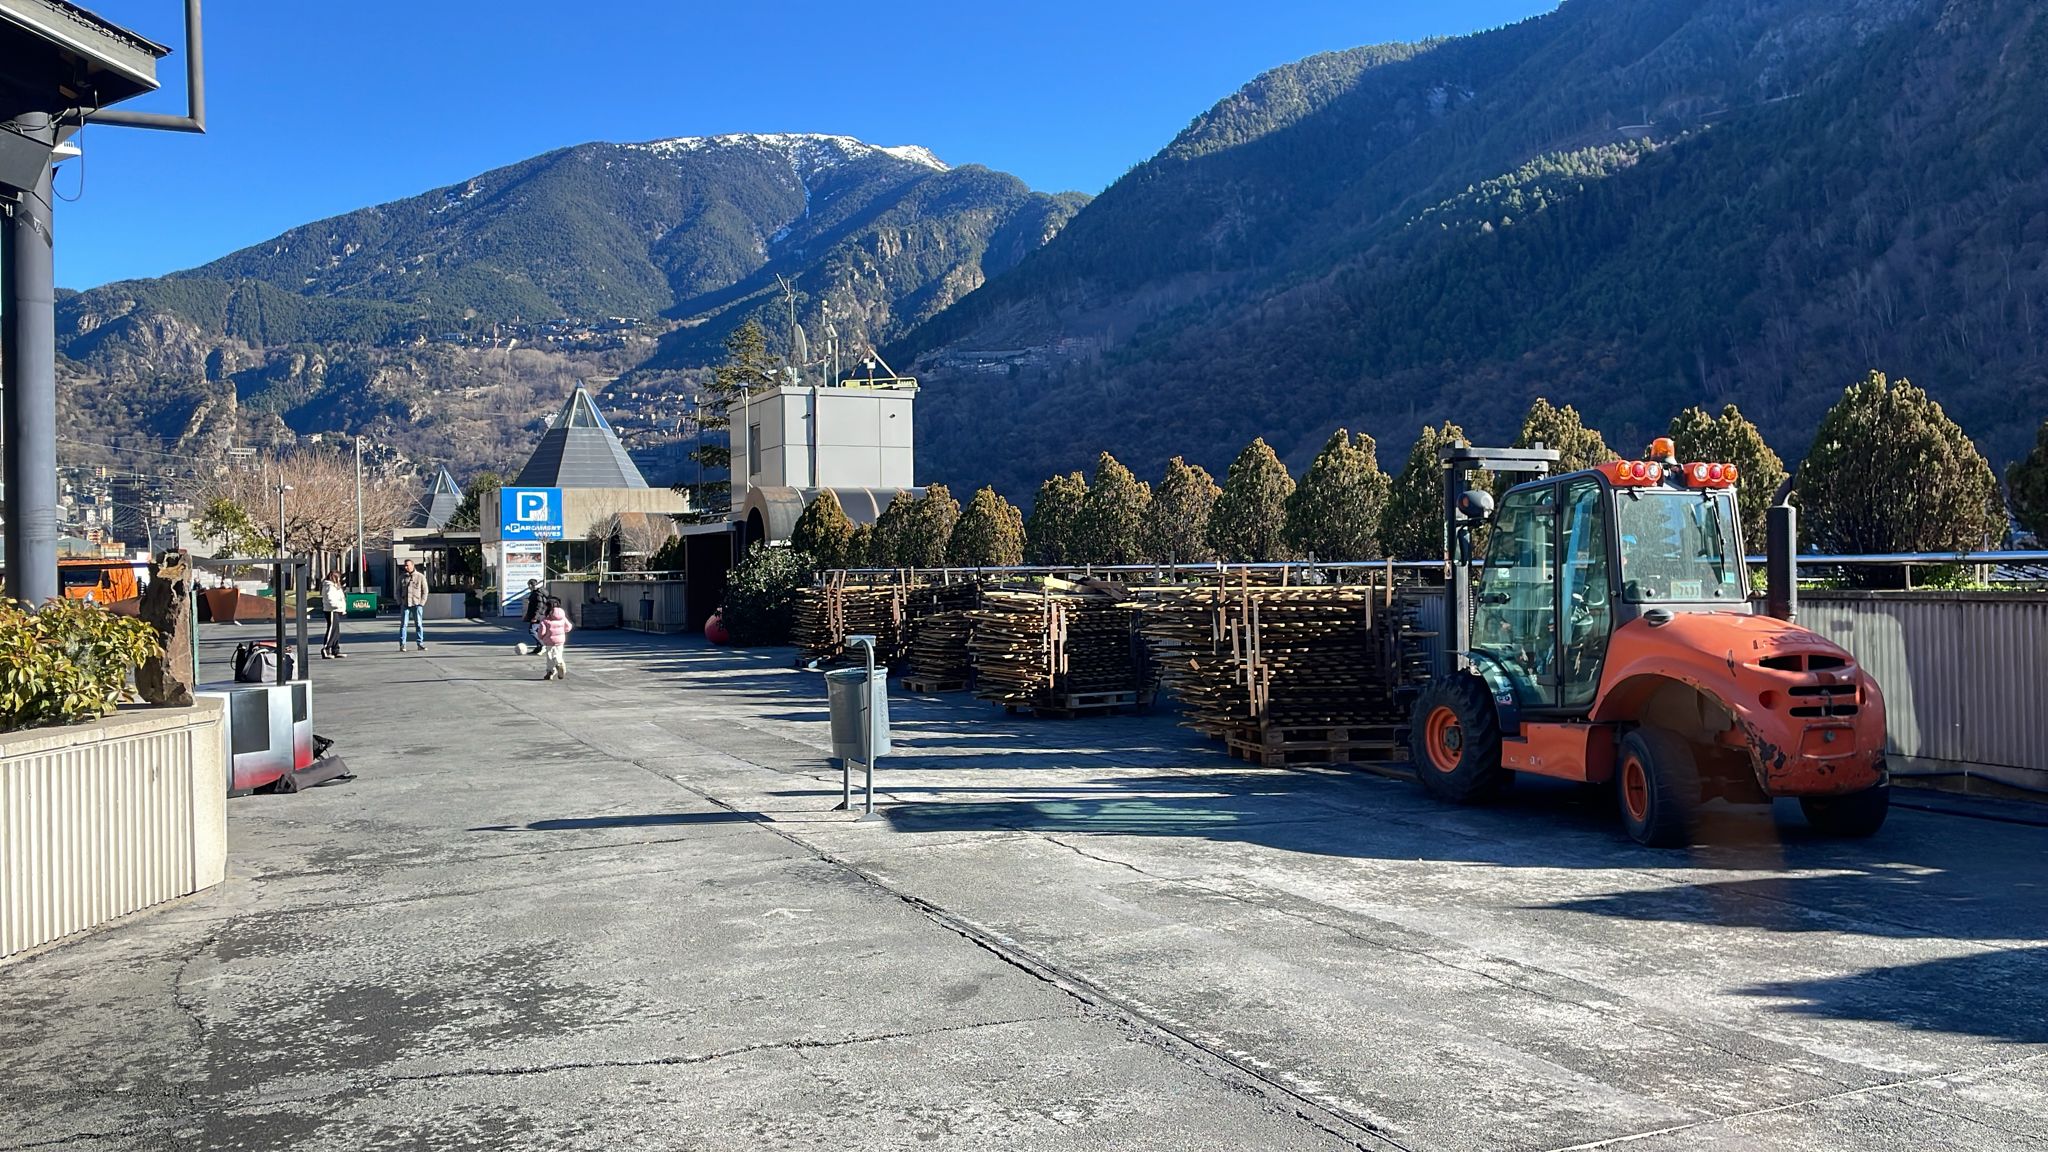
[0,625,2048,1150]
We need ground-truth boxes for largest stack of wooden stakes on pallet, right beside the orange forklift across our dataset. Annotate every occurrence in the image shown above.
[1145,578,1427,767]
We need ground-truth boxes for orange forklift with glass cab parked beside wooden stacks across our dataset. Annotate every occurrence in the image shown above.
[1409,439,1890,847]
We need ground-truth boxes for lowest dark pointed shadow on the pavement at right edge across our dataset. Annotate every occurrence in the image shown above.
[1743,947,2048,1043]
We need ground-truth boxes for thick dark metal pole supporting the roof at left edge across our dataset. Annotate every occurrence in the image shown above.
[0,123,57,605]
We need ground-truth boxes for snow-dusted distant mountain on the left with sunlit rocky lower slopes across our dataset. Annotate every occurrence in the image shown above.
[57,133,1085,469]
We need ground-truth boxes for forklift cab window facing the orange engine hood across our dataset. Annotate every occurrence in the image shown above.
[1614,488,1749,605]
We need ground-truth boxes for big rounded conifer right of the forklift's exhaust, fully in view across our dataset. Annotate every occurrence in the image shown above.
[1794,371,2005,553]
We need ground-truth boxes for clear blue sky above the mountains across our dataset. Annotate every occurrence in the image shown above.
[57,0,1556,289]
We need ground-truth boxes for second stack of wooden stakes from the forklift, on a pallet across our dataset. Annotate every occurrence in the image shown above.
[967,582,1143,715]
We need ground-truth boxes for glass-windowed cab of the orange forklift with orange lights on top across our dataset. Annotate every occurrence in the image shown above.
[1468,453,1751,713]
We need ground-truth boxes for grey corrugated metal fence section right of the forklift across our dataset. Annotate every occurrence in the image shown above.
[1798,592,2048,783]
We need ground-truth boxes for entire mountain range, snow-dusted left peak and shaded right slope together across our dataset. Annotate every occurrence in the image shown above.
[44,0,2048,498]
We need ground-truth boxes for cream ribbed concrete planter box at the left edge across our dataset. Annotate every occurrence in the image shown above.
[0,699,227,961]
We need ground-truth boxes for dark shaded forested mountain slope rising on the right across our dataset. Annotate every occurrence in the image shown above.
[897,0,2048,496]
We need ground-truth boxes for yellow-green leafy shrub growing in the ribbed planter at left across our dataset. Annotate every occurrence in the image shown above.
[0,601,162,732]
